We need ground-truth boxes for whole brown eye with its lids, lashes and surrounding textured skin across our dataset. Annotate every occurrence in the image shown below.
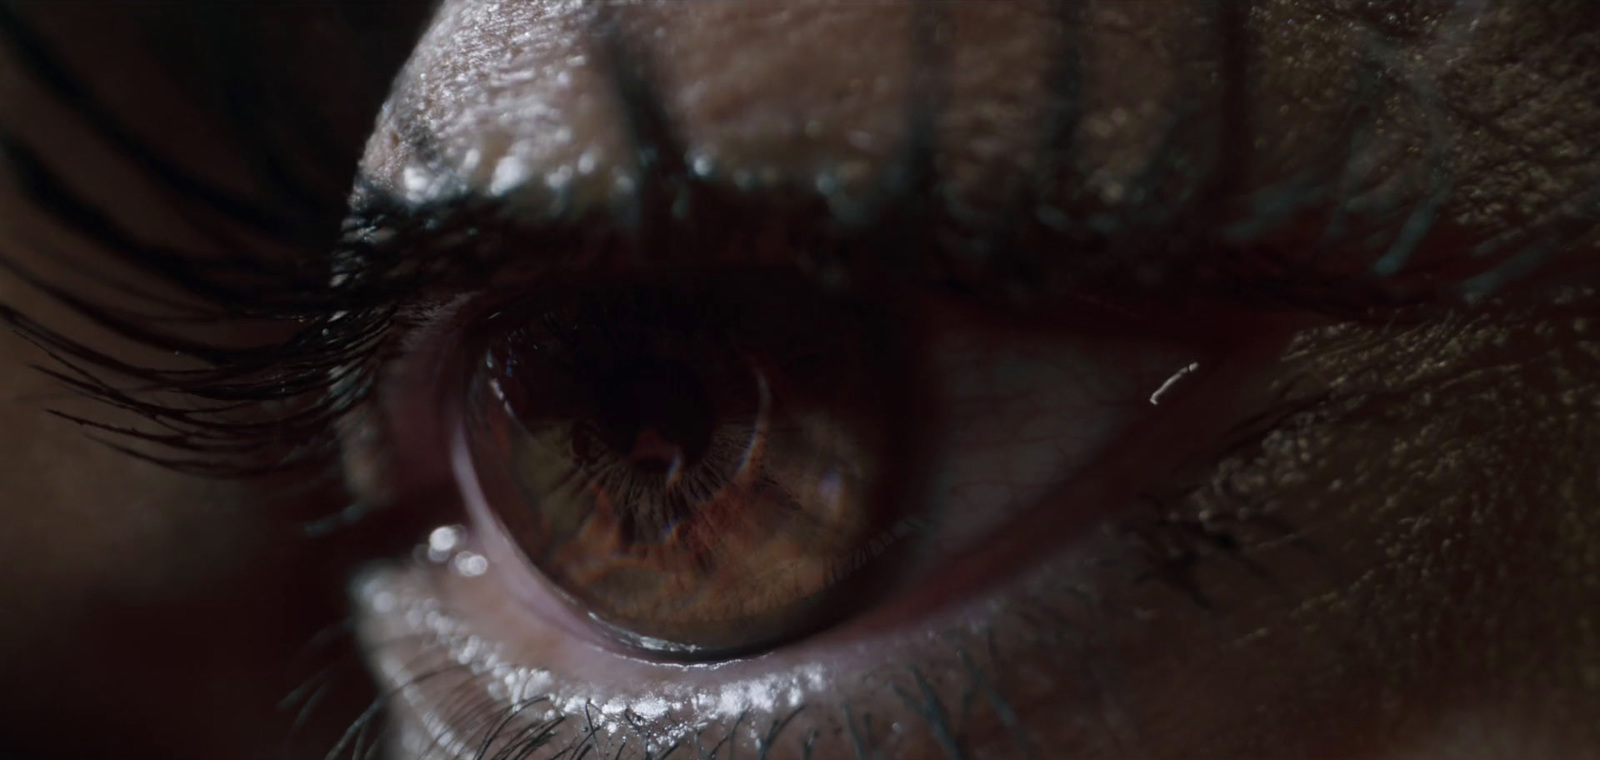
[6,0,1600,758]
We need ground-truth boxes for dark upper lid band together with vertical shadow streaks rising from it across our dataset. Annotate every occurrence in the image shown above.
[352,0,1510,326]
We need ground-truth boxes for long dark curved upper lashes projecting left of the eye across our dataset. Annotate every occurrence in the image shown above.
[0,5,390,477]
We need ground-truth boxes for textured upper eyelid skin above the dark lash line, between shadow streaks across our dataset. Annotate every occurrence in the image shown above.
[363,0,1600,280]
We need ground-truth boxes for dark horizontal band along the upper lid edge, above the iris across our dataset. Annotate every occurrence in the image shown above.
[342,176,1445,328]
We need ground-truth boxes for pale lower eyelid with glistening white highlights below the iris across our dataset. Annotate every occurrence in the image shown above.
[355,518,1139,757]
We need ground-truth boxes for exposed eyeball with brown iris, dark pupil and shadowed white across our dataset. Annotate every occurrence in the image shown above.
[427,280,1235,659]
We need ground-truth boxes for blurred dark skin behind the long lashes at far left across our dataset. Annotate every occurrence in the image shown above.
[0,3,426,757]
